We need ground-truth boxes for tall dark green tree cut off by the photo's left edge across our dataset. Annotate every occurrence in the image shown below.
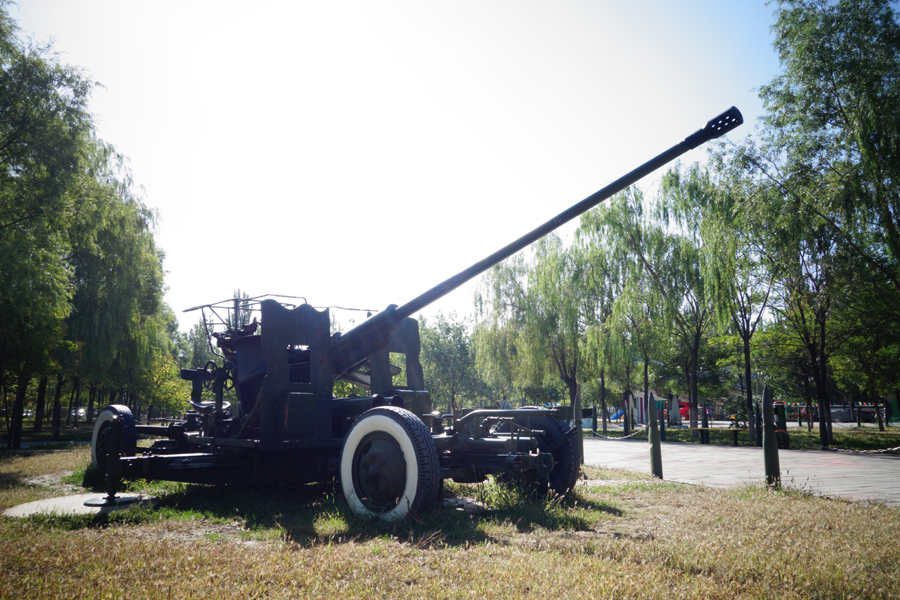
[0,2,93,446]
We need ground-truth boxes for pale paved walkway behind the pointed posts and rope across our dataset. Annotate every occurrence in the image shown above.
[584,437,900,507]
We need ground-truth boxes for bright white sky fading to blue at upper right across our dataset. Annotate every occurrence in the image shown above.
[10,0,779,330]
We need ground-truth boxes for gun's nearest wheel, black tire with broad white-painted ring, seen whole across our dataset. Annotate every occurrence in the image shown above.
[340,406,441,521]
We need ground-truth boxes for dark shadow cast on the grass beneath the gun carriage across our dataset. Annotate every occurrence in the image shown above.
[30,467,622,548]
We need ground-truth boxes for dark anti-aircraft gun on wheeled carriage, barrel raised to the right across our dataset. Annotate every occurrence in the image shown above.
[91,107,743,519]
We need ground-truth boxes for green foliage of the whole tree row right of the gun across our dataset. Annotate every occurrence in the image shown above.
[468,0,900,424]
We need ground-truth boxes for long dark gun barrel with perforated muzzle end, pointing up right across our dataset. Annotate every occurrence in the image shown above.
[334,106,744,375]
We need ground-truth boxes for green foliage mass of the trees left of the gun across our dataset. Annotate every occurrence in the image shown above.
[0,2,185,438]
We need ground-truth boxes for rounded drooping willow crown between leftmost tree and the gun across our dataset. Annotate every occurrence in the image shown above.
[67,141,171,422]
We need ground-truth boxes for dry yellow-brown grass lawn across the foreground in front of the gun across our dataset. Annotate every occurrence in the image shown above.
[0,457,900,600]
